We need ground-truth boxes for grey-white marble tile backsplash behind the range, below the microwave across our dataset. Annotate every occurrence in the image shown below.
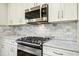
[15,22,77,40]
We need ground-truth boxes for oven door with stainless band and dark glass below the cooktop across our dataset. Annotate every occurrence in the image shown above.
[17,44,41,56]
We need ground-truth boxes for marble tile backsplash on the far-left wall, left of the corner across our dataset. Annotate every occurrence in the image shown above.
[0,26,16,37]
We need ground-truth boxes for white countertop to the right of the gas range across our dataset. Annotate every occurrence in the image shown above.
[44,39,79,52]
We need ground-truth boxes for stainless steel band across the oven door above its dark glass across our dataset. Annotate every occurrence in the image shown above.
[18,44,41,56]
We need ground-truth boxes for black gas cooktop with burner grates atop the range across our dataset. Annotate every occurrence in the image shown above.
[17,36,50,45]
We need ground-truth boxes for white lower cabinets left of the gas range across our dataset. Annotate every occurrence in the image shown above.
[0,42,17,56]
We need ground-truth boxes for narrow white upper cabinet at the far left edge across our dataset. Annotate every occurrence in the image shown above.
[0,3,8,25]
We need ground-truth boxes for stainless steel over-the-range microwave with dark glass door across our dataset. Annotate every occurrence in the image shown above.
[25,4,48,24]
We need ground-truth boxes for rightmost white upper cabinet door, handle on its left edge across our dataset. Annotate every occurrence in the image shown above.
[61,3,77,20]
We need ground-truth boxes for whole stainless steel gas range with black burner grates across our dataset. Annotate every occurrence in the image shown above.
[16,36,50,56]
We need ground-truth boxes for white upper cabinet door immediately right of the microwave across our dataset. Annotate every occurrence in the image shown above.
[48,3,60,22]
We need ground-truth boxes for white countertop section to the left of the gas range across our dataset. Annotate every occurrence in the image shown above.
[0,35,23,46]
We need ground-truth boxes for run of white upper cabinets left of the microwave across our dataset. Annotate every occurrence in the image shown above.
[0,3,31,25]
